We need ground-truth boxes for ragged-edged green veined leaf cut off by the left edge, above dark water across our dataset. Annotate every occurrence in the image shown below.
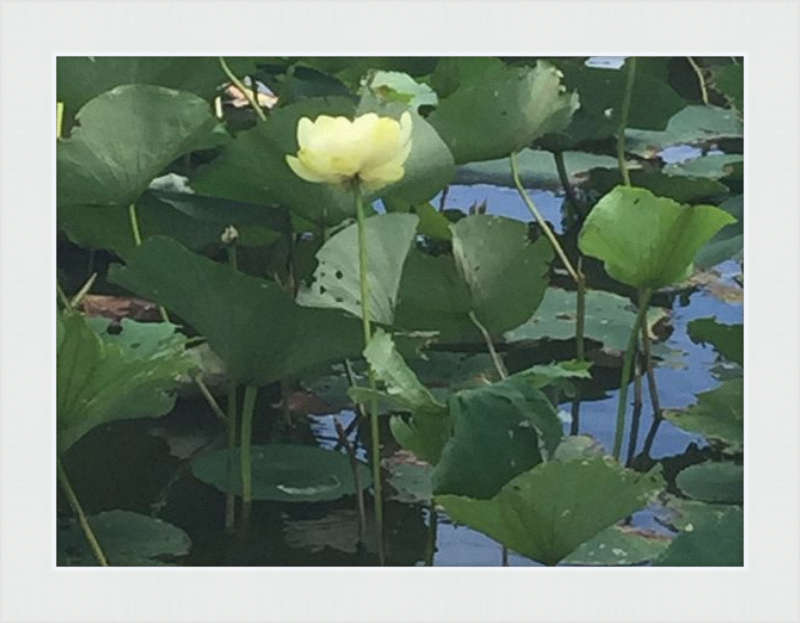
[56,312,193,454]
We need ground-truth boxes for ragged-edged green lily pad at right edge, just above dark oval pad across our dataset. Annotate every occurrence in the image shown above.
[664,378,744,450]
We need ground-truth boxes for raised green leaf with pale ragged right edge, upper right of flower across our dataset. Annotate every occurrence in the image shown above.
[428,61,578,164]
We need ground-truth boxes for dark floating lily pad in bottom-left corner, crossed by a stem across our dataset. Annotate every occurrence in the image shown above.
[57,510,192,567]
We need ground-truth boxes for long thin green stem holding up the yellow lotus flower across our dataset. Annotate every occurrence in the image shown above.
[353,181,386,565]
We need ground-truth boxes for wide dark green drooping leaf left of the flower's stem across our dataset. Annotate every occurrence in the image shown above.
[109,237,363,385]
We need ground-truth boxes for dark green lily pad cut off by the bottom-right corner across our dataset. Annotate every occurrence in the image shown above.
[654,507,744,567]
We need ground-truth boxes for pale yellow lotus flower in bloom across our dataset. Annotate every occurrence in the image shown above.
[286,112,411,191]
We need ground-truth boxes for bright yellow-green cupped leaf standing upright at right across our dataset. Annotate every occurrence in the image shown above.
[578,187,735,289]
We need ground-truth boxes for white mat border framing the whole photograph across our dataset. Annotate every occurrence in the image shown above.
[0,0,800,623]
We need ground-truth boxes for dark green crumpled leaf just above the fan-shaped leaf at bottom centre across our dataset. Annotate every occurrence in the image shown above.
[433,376,562,499]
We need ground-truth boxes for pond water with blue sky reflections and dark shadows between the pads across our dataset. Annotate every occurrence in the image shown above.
[57,174,743,566]
